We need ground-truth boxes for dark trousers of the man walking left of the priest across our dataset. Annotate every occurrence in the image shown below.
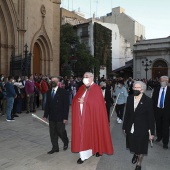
[49,121,69,150]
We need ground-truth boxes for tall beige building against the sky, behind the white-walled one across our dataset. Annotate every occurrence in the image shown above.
[100,7,145,49]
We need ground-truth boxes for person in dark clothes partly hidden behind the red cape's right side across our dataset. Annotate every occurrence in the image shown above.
[100,82,113,122]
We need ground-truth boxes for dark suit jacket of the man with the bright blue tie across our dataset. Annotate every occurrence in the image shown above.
[152,86,170,116]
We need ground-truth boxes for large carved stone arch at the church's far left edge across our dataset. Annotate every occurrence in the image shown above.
[0,0,17,75]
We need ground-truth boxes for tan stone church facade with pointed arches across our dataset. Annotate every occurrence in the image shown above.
[0,0,61,76]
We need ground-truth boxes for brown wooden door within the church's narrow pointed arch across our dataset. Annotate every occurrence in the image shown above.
[33,42,41,75]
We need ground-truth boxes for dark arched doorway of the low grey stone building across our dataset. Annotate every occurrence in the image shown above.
[152,58,168,79]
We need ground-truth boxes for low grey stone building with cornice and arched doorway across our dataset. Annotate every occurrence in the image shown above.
[133,37,170,79]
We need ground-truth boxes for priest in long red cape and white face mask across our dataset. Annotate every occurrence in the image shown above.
[71,72,113,164]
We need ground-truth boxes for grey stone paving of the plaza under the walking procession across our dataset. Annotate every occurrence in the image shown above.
[0,89,170,170]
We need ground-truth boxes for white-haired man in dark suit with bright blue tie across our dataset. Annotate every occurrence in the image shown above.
[152,76,170,149]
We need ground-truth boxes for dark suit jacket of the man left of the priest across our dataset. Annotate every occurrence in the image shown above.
[44,87,69,122]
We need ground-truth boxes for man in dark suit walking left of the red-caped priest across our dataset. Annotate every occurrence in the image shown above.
[44,77,69,154]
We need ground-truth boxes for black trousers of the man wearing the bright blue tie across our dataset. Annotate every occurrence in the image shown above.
[155,108,169,145]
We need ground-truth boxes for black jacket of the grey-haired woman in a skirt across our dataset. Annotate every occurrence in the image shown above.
[123,94,155,136]
